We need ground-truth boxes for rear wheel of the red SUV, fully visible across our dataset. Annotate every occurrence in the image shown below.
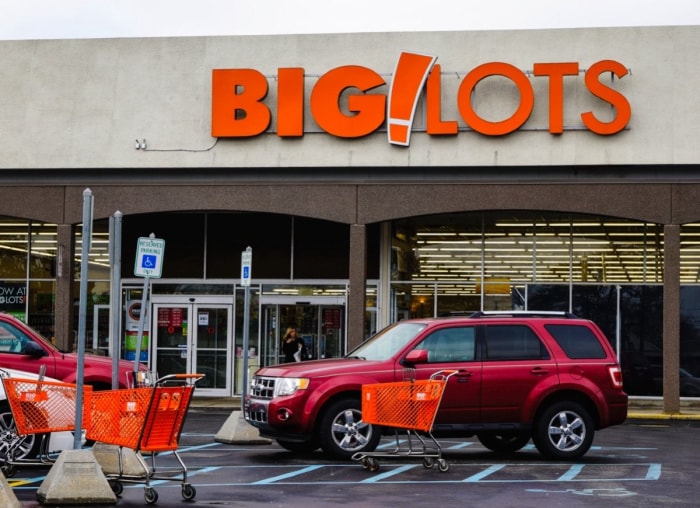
[532,401,594,460]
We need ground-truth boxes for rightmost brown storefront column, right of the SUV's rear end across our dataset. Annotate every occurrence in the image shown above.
[663,224,681,413]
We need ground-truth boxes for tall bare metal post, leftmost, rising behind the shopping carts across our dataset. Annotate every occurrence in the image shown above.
[73,189,93,450]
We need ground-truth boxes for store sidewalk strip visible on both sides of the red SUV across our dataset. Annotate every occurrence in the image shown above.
[190,394,700,420]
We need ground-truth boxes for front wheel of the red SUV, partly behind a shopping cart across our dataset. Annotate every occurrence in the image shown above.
[319,398,382,459]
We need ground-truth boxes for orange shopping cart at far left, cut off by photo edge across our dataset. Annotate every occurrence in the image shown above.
[0,375,92,477]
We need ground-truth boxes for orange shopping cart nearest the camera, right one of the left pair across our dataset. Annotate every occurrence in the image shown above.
[87,374,204,504]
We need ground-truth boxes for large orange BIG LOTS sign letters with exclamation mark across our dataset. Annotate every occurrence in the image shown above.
[212,52,632,146]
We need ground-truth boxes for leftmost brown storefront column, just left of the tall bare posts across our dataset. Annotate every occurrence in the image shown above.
[54,224,75,351]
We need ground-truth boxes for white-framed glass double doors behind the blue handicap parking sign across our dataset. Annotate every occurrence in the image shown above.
[152,303,233,395]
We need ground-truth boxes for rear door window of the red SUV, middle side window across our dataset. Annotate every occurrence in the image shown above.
[484,325,549,360]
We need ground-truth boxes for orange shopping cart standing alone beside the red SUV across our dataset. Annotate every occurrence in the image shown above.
[352,370,457,472]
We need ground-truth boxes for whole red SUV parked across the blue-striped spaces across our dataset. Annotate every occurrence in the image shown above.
[244,312,627,460]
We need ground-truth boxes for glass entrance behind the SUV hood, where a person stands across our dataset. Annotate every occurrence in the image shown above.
[261,303,345,365]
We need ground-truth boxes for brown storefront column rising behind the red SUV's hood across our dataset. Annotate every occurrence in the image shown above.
[347,224,367,351]
